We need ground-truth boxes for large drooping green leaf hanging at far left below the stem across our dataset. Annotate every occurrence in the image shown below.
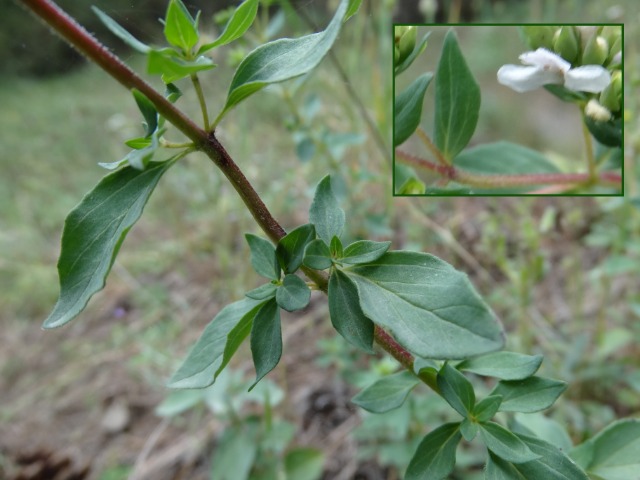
[43,160,175,328]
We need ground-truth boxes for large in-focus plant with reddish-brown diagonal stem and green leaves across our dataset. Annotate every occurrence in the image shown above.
[17,0,640,480]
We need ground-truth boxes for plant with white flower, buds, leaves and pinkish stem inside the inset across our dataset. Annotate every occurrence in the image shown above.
[393,25,623,195]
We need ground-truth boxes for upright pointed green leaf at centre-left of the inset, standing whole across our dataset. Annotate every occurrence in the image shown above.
[434,30,480,159]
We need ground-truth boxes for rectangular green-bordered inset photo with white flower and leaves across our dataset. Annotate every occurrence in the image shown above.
[393,24,624,196]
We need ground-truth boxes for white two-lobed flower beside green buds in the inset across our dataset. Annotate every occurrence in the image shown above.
[498,48,611,93]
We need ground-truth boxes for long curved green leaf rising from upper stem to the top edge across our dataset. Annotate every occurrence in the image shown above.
[216,0,349,123]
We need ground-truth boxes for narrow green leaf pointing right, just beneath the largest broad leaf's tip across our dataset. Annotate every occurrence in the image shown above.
[456,352,543,380]
